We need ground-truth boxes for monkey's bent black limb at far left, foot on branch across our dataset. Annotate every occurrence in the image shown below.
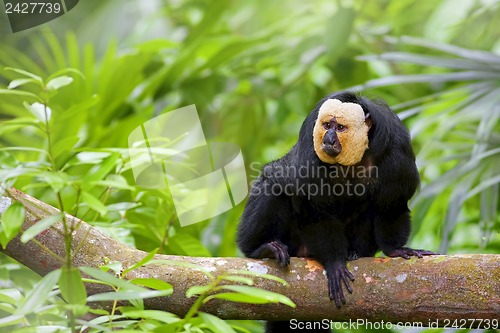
[237,176,293,266]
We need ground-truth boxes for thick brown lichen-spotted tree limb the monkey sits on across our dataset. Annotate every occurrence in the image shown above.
[0,189,500,327]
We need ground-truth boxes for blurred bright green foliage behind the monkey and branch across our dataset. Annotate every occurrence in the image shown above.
[0,0,500,330]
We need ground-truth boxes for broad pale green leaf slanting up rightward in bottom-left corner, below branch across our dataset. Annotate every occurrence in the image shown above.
[16,269,61,315]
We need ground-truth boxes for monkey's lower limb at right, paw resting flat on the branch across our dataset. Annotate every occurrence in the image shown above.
[375,207,438,259]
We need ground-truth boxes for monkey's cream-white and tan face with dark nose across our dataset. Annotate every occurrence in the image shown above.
[313,99,371,165]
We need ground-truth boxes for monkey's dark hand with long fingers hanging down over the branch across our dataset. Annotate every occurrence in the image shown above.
[325,261,354,308]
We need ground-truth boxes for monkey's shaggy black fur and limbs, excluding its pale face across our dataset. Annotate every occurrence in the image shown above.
[238,92,434,330]
